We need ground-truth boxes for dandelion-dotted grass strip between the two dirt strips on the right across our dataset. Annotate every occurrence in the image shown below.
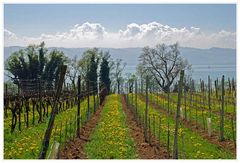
[126,95,235,159]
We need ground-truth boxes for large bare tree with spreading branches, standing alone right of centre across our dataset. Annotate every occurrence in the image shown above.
[140,43,191,92]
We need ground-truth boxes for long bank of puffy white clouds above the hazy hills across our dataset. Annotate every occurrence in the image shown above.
[4,22,236,48]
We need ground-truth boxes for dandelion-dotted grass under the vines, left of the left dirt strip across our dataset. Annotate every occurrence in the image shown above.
[4,97,97,159]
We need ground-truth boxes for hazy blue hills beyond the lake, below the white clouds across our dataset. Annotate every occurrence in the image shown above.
[4,46,236,65]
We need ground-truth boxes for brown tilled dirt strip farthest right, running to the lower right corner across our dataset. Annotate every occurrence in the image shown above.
[140,96,236,156]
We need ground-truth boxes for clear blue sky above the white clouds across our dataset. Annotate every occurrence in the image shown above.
[4,4,236,48]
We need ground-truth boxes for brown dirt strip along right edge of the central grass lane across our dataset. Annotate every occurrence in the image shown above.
[121,95,168,159]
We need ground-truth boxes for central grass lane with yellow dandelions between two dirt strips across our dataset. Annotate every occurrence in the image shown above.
[84,94,137,159]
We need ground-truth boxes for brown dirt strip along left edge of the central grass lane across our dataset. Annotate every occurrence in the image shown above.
[59,100,105,159]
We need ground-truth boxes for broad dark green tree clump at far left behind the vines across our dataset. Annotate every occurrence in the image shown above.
[5,42,67,88]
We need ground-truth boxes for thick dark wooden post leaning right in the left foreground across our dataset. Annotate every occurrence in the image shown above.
[39,65,67,159]
